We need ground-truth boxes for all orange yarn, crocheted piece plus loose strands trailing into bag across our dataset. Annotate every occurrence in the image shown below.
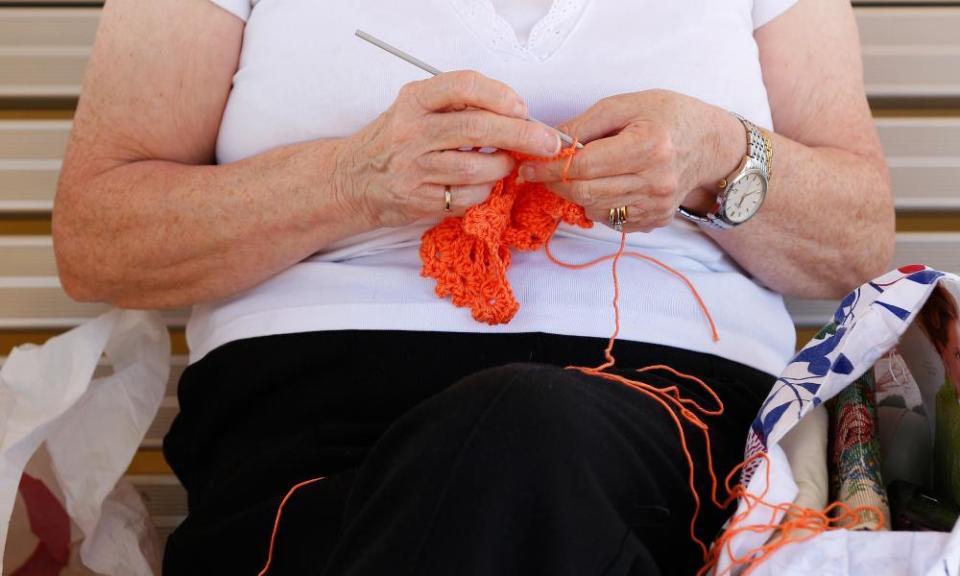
[259,146,883,576]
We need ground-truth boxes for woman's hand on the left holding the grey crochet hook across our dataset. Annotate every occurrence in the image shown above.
[337,71,560,228]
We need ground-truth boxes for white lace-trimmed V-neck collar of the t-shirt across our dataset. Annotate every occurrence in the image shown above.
[450,0,590,61]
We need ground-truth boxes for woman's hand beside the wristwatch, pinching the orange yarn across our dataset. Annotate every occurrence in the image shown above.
[520,90,747,232]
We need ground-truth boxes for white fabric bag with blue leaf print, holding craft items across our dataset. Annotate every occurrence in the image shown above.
[716,265,960,576]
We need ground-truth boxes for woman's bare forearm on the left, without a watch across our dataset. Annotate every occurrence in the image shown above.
[53,141,369,308]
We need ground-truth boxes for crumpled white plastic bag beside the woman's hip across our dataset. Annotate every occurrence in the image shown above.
[0,310,170,576]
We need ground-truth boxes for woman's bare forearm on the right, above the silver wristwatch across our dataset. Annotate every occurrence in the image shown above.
[704,116,894,298]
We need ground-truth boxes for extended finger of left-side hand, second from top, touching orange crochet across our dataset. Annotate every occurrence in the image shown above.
[425,110,560,157]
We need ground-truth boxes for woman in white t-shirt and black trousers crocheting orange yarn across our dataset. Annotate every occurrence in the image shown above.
[54,0,893,575]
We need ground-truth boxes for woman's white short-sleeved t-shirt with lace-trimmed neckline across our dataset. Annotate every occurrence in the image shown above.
[187,0,796,373]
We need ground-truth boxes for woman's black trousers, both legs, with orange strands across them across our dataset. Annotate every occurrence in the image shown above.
[164,331,774,576]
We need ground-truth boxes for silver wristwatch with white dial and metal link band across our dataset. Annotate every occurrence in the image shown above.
[677,112,773,230]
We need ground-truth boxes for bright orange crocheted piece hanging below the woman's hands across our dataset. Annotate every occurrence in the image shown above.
[420,146,593,324]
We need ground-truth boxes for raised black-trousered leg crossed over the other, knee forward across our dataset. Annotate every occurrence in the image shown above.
[329,363,763,574]
